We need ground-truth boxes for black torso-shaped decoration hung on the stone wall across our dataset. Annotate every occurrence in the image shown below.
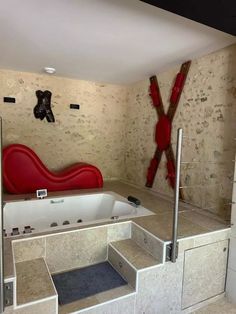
[34,90,55,122]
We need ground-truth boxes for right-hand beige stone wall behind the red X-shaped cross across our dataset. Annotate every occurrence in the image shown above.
[125,45,236,217]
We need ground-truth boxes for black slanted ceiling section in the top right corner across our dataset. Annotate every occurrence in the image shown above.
[140,0,236,35]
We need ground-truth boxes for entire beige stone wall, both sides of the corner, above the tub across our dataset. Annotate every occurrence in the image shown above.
[0,45,236,218]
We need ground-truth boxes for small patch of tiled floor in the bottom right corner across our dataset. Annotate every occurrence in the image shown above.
[192,298,236,314]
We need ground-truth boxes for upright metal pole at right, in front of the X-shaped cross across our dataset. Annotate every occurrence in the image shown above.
[171,129,183,263]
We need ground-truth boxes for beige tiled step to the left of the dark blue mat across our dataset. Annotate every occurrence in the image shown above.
[15,258,57,307]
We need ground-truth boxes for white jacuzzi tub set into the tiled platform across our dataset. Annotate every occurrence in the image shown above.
[4,192,153,236]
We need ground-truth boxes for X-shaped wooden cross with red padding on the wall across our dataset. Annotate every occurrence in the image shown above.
[146,61,191,199]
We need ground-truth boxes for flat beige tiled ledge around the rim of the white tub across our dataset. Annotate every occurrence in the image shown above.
[4,181,229,241]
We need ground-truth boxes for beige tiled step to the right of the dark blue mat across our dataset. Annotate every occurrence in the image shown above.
[108,239,162,274]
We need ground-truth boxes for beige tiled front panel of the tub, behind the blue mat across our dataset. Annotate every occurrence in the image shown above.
[12,222,131,273]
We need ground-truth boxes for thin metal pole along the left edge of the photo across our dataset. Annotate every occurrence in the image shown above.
[0,117,5,313]
